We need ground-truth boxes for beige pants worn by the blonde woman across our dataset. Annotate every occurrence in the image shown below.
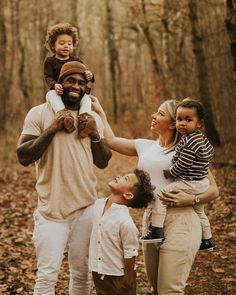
[143,207,201,295]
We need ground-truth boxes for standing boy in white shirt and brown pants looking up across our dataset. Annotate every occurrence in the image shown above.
[89,169,154,295]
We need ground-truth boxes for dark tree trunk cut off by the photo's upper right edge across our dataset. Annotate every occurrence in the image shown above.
[225,0,236,82]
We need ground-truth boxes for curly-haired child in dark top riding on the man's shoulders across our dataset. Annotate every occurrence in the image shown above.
[44,23,94,137]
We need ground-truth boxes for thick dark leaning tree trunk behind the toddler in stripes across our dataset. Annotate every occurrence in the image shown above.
[188,0,220,146]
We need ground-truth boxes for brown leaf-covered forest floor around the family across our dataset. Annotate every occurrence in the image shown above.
[0,146,236,295]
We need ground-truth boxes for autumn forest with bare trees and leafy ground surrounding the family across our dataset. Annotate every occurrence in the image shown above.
[0,0,236,295]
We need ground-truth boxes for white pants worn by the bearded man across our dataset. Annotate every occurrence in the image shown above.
[33,205,93,295]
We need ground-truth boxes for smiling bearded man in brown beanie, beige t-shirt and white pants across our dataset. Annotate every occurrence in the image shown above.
[17,61,111,295]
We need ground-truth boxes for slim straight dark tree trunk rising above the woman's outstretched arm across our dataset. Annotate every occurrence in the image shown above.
[106,0,118,123]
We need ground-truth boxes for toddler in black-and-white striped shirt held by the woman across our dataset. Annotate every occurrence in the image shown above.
[141,98,214,251]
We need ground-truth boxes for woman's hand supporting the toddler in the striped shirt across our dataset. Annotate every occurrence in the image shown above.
[160,191,195,207]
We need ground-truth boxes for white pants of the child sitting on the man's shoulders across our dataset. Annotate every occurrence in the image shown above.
[46,90,91,115]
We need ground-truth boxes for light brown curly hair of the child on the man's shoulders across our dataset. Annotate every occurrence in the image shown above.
[45,23,79,53]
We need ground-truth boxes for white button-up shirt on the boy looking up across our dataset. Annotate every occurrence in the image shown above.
[89,198,139,276]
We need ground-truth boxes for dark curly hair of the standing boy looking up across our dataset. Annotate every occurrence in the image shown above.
[128,169,155,208]
